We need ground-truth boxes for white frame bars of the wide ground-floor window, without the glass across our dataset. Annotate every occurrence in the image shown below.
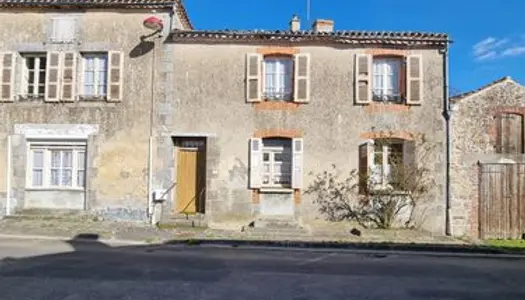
[26,141,87,190]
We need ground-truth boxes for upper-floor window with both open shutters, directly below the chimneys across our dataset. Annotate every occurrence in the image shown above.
[245,53,310,103]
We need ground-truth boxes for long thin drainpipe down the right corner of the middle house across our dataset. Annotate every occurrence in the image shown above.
[441,44,452,236]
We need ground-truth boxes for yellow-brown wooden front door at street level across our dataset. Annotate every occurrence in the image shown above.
[175,148,204,214]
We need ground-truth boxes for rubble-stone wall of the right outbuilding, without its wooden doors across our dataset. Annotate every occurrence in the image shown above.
[451,77,525,237]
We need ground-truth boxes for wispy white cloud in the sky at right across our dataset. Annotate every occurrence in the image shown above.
[472,36,525,61]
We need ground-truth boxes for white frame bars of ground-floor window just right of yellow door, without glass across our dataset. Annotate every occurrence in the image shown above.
[261,138,293,188]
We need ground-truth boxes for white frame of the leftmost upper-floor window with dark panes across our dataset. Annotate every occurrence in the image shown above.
[19,53,48,99]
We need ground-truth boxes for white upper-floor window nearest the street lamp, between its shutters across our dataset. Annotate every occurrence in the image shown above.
[82,53,108,98]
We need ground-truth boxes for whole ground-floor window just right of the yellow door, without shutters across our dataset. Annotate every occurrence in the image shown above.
[261,138,292,187]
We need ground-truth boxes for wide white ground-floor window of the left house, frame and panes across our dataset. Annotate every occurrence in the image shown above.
[28,142,86,189]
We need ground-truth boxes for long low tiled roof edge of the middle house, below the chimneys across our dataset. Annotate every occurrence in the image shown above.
[168,29,451,47]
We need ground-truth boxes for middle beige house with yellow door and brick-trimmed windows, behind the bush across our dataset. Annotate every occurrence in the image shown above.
[155,17,449,233]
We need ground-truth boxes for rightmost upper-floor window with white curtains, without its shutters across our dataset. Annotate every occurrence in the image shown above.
[372,57,402,102]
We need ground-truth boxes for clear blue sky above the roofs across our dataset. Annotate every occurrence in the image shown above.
[184,0,525,91]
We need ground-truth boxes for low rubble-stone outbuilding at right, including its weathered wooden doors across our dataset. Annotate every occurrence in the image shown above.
[451,77,525,238]
